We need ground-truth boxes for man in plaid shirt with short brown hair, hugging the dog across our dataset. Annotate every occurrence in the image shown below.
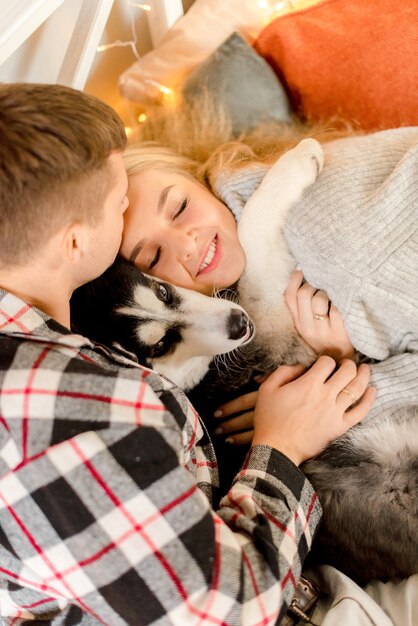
[0,84,373,626]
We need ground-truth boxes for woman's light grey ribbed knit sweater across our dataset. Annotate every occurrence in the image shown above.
[214,127,418,412]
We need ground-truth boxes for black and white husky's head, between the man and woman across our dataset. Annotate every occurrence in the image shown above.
[70,257,254,391]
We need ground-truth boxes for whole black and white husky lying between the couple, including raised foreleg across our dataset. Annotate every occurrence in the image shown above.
[72,140,418,583]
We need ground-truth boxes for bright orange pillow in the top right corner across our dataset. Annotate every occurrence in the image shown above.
[255,0,418,130]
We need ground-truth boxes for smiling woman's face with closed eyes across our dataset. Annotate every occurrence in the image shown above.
[120,169,245,294]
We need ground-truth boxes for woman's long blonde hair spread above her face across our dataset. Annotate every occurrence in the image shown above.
[124,92,354,189]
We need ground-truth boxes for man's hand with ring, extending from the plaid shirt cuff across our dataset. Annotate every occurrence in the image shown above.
[253,356,376,465]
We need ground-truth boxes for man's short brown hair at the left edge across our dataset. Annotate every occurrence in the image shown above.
[0,83,126,266]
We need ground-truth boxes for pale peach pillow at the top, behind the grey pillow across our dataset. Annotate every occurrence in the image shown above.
[119,0,318,104]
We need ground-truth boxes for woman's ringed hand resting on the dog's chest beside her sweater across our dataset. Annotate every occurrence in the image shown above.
[285,271,355,361]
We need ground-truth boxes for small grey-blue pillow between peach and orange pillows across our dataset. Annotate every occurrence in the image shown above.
[183,33,289,136]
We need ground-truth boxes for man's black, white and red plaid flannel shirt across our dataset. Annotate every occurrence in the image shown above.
[0,291,321,626]
